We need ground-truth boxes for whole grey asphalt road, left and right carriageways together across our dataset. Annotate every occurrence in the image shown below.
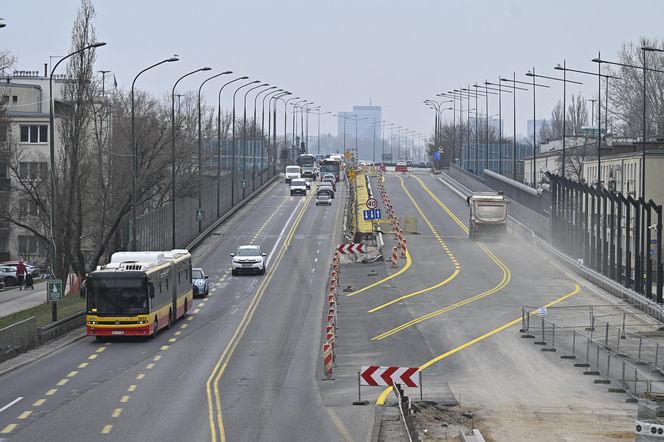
[0,171,634,441]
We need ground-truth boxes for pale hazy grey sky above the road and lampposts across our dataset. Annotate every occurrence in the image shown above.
[0,0,664,141]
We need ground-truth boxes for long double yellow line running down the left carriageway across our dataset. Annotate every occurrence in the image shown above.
[205,188,314,442]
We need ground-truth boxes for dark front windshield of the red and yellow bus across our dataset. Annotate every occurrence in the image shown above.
[87,276,149,316]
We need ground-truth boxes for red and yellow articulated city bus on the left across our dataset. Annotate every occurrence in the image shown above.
[81,249,193,338]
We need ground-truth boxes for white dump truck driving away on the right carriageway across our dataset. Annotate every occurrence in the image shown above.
[466,192,508,239]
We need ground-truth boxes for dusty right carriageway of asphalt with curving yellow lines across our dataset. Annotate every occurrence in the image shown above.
[335,171,635,440]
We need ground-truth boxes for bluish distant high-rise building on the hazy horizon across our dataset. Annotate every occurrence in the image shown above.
[337,106,382,160]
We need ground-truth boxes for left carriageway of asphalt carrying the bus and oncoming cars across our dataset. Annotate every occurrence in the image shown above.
[0,182,368,441]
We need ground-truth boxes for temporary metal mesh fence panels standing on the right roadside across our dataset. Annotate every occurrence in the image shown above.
[522,305,664,397]
